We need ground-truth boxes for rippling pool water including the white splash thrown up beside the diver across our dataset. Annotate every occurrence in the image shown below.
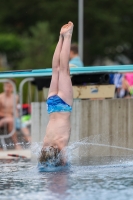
[0,136,133,200]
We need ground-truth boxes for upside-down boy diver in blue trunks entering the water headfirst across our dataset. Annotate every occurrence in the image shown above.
[39,22,74,166]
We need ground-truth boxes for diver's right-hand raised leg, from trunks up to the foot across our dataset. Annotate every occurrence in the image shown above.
[58,22,73,106]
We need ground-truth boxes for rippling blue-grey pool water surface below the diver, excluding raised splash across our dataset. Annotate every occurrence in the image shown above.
[0,160,133,200]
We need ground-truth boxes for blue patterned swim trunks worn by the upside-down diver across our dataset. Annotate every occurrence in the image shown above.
[47,95,72,114]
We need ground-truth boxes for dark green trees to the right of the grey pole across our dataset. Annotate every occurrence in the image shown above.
[84,0,133,63]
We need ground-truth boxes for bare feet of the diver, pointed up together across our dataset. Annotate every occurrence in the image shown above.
[60,22,74,36]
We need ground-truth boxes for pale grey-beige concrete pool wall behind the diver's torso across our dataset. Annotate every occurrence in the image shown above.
[31,99,133,157]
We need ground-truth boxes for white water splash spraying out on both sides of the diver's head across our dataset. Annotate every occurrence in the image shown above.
[30,135,133,166]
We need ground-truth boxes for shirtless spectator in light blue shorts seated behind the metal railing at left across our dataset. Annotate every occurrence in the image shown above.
[0,79,30,149]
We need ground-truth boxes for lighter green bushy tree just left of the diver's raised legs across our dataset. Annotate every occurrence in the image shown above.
[19,22,54,69]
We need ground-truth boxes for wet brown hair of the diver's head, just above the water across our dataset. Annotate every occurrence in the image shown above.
[39,146,62,166]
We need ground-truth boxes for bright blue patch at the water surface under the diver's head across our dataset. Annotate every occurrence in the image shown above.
[37,163,70,172]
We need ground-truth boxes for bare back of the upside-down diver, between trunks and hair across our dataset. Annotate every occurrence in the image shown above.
[43,112,71,150]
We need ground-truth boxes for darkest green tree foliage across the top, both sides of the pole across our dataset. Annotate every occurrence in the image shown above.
[0,0,133,67]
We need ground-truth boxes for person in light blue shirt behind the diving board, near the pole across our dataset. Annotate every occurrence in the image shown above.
[69,44,84,67]
